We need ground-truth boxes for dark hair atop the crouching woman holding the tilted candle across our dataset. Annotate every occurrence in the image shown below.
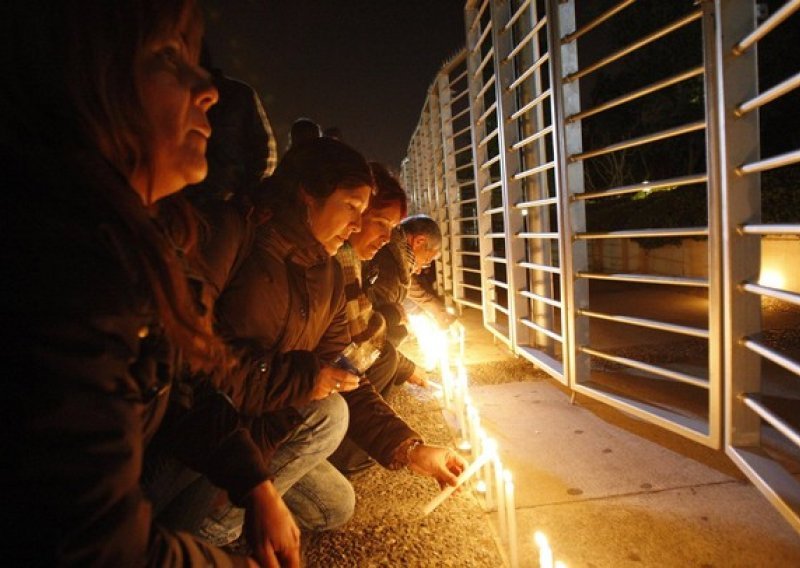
[252,138,375,215]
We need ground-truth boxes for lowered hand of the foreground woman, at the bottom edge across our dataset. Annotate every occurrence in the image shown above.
[244,481,300,568]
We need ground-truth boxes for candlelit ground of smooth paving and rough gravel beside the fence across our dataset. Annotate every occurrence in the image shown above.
[308,304,800,568]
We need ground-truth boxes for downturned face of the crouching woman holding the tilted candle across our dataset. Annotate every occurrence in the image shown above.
[304,185,372,256]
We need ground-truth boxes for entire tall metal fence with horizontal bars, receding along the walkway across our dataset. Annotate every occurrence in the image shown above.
[405,0,800,530]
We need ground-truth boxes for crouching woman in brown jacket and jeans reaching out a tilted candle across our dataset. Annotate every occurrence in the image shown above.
[209,138,464,530]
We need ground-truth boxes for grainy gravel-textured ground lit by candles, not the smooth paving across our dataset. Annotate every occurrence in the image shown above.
[306,361,516,568]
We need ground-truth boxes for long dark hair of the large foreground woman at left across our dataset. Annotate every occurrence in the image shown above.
[0,0,223,378]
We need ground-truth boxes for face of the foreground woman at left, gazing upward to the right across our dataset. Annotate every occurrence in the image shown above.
[131,23,219,204]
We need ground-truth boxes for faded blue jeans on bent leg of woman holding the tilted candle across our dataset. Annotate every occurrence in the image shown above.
[270,393,356,531]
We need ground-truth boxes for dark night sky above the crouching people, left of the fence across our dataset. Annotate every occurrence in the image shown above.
[201,0,465,169]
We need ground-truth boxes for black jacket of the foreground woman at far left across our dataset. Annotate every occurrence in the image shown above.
[0,140,252,566]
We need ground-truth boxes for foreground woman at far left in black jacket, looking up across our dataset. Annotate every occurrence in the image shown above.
[0,0,299,567]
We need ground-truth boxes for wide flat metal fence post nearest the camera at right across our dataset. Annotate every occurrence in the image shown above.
[714,0,761,446]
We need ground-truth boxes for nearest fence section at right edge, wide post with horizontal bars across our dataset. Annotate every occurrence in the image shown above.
[714,0,800,531]
